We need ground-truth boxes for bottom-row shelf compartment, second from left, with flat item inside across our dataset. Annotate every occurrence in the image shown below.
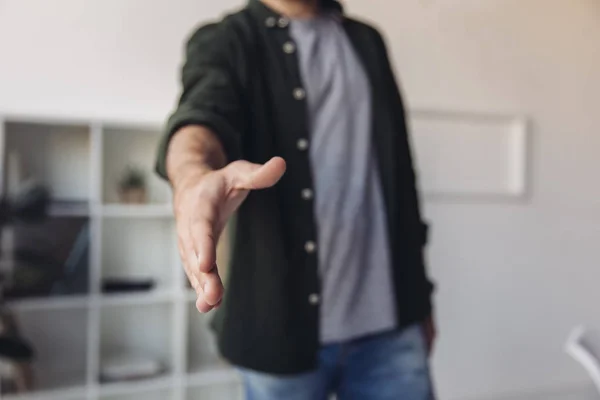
[98,304,174,384]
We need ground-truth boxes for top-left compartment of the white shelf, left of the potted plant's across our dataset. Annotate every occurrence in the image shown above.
[4,122,90,202]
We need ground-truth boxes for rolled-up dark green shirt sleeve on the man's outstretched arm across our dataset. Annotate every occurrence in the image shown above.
[156,24,244,179]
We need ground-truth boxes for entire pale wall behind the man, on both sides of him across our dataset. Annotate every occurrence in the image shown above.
[0,0,600,400]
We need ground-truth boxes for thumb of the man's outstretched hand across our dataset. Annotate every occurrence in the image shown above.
[222,157,286,190]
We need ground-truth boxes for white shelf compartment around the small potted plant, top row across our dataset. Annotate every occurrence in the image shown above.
[102,126,170,204]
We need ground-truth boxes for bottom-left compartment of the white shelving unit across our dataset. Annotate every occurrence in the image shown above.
[0,309,88,397]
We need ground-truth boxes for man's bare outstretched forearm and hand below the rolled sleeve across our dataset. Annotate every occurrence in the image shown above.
[166,125,285,312]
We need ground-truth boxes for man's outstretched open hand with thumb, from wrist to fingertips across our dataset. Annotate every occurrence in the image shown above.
[174,157,286,313]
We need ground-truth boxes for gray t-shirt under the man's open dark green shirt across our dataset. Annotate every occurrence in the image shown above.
[290,14,396,343]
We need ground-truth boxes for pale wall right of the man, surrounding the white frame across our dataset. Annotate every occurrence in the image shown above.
[351,0,600,399]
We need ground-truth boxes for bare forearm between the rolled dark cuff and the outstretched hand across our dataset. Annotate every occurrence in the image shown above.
[166,125,227,189]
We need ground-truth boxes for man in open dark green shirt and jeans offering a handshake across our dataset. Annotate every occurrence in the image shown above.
[157,0,433,400]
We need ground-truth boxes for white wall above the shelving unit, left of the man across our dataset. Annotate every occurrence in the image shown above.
[0,0,243,122]
